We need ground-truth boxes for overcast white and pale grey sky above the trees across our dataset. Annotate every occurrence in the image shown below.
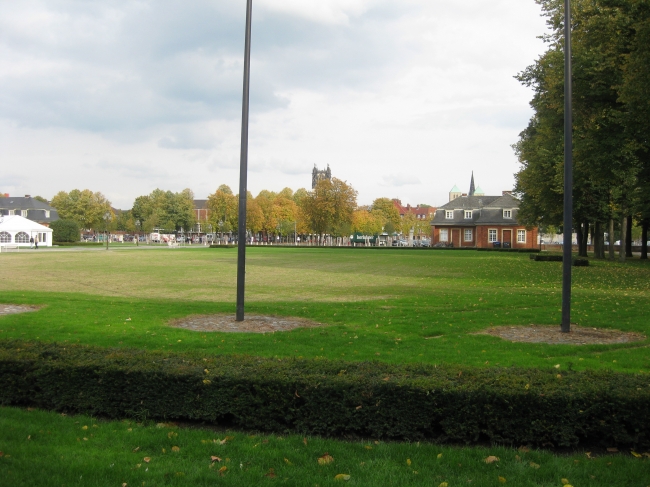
[0,0,546,209]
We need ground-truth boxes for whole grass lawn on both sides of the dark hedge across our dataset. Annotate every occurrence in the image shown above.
[0,247,650,487]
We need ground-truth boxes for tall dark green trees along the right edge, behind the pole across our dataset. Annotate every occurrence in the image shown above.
[514,0,650,259]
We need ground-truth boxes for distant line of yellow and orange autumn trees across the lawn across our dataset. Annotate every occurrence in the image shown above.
[52,178,430,237]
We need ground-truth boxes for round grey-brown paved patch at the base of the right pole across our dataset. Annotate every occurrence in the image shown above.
[476,325,646,345]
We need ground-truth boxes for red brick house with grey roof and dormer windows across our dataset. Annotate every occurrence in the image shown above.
[431,193,537,249]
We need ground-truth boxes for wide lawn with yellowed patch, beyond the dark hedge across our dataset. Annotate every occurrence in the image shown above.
[0,248,650,373]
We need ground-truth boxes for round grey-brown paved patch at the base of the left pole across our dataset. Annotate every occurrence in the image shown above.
[169,314,322,333]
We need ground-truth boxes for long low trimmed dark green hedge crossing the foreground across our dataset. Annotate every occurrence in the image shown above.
[0,341,650,448]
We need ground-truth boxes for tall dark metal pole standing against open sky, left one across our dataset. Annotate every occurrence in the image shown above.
[235,0,253,321]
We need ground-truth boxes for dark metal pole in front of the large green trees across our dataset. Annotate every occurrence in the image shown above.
[561,0,573,333]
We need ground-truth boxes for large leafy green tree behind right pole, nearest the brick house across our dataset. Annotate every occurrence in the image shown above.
[515,0,648,256]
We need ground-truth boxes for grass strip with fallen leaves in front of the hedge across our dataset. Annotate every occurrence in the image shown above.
[0,407,650,487]
